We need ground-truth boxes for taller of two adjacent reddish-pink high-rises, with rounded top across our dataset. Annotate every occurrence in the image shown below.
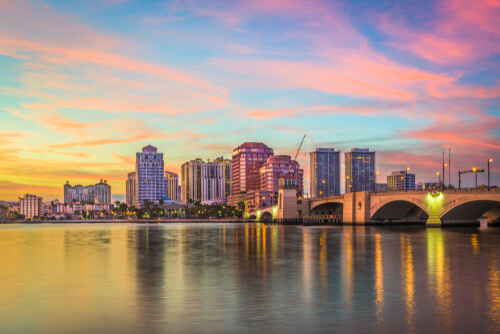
[228,142,274,206]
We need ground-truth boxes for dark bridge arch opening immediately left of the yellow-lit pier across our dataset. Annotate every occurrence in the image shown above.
[370,199,429,222]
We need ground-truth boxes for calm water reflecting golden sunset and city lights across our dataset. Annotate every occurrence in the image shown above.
[0,223,500,333]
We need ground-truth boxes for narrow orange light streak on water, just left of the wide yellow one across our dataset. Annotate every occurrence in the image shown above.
[401,234,417,332]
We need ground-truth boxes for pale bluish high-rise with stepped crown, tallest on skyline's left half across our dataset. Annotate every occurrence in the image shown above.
[133,145,165,208]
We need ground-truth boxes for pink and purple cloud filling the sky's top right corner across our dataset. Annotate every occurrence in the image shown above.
[378,0,500,64]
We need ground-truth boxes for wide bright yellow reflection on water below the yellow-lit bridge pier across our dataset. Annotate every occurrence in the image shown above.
[426,228,453,331]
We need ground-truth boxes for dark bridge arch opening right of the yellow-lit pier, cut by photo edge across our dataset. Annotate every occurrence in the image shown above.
[440,199,500,223]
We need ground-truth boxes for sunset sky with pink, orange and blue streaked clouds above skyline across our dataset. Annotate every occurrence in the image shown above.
[0,0,500,200]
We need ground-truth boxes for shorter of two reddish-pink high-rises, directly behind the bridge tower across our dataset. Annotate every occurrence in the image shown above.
[259,155,304,198]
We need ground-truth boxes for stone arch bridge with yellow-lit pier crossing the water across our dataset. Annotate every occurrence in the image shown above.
[247,189,500,226]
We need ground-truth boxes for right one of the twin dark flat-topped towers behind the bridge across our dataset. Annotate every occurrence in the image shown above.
[345,148,375,193]
